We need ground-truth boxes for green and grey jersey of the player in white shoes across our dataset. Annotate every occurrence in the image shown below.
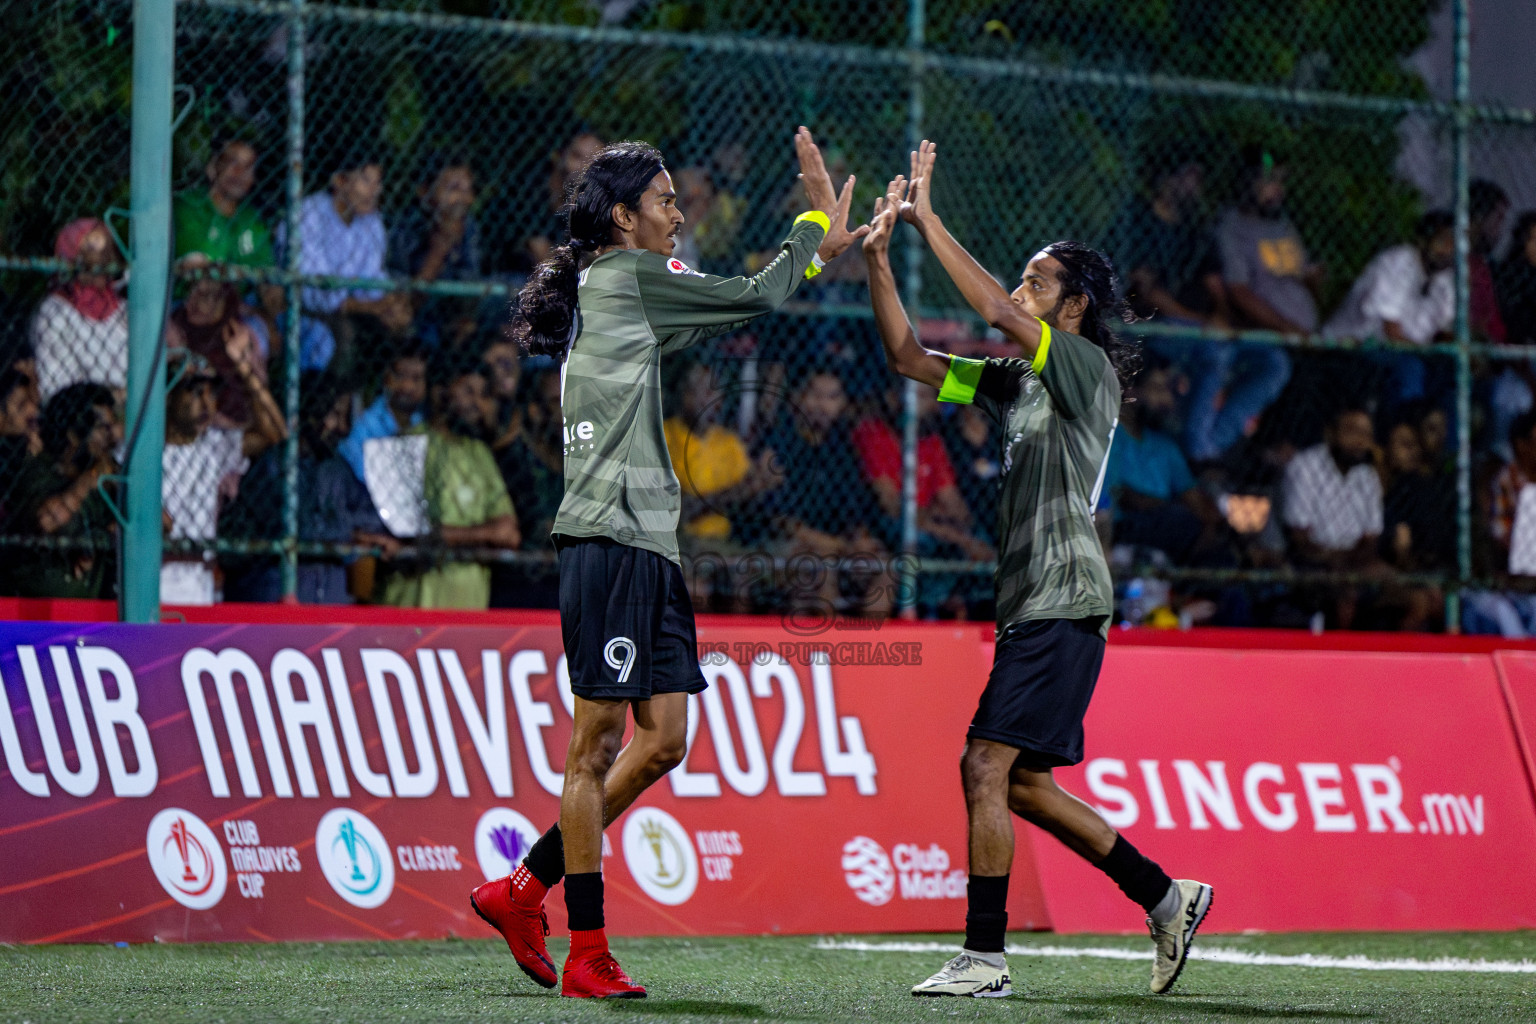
[938,322,1120,636]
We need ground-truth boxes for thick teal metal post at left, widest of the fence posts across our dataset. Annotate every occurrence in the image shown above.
[118,0,177,622]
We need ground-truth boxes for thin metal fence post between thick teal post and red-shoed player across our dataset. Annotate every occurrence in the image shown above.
[283,0,304,602]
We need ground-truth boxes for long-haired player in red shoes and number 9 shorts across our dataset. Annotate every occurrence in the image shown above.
[470,127,868,998]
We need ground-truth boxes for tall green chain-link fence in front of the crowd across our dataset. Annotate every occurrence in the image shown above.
[0,0,1536,631]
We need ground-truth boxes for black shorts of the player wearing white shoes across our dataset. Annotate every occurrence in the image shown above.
[966,616,1104,768]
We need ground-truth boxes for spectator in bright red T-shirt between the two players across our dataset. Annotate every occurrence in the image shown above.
[849,385,997,562]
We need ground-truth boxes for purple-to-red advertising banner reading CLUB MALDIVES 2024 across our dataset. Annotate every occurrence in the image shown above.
[0,617,1048,943]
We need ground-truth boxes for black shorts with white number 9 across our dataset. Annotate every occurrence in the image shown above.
[554,536,705,700]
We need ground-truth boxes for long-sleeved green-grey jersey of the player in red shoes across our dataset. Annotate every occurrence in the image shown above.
[553,216,826,562]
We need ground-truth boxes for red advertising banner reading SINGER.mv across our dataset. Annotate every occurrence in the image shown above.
[1037,645,1536,932]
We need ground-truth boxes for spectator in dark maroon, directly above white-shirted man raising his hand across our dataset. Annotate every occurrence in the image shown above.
[166,278,270,430]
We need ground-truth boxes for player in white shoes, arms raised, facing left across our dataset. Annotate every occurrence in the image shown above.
[865,141,1210,996]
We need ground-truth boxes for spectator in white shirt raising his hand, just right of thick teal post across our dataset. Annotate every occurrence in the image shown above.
[160,348,287,605]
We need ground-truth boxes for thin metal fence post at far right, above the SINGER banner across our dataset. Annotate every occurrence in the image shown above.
[1445,0,1471,633]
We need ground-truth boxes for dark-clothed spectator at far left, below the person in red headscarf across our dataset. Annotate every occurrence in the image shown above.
[6,384,121,599]
